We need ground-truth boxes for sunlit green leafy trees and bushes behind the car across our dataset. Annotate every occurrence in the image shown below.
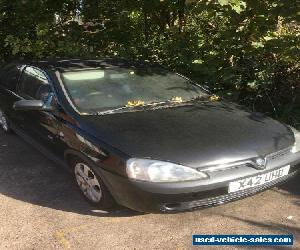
[0,0,300,128]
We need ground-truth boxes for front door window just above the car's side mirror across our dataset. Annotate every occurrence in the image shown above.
[18,67,49,99]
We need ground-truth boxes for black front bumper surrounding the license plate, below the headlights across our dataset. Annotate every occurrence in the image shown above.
[101,155,300,212]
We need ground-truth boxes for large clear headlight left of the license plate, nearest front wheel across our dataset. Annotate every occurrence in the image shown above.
[126,158,209,182]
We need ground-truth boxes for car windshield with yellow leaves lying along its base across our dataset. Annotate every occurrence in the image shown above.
[62,68,207,113]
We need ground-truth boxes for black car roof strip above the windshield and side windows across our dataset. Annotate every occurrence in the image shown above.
[5,58,161,72]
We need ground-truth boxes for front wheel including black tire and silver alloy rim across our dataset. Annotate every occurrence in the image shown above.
[71,158,116,210]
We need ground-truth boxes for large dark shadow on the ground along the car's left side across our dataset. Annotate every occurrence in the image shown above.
[0,132,140,217]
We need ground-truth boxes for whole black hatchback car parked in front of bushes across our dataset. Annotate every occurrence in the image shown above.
[0,59,300,212]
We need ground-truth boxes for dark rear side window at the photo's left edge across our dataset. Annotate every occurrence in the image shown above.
[0,64,21,91]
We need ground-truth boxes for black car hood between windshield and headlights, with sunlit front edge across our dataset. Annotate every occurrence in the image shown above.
[82,102,294,168]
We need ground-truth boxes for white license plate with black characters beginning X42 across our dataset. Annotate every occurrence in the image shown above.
[228,166,290,193]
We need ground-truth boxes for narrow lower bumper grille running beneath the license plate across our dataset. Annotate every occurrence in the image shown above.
[161,171,297,212]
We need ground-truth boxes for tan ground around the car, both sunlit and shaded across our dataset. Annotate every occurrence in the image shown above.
[0,132,300,250]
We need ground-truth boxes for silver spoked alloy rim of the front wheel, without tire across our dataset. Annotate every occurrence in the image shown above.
[75,163,102,203]
